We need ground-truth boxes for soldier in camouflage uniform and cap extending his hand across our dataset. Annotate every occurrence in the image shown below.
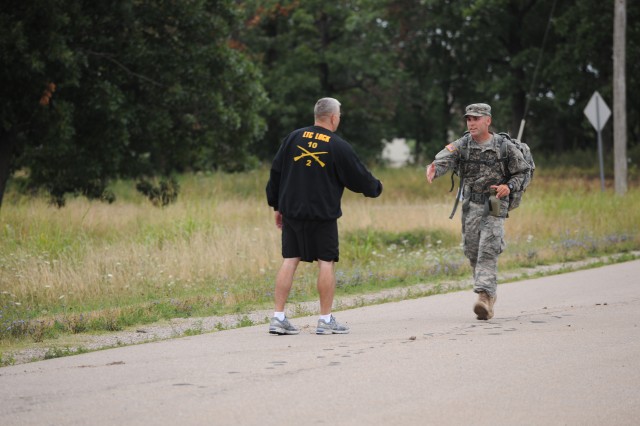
[426,104,529,320]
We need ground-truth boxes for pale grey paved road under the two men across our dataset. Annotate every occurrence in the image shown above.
[0,261,640,426]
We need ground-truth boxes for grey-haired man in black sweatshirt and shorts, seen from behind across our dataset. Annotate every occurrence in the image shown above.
[266,98,382,334]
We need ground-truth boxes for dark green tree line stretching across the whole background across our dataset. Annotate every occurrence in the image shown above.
[0,0,640,204]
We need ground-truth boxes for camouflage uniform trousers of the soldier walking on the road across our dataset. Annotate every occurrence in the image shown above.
[462,203,506,297]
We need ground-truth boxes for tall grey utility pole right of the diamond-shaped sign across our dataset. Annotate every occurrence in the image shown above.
[613,0,627,195]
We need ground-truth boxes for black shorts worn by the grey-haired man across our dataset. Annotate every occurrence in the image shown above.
[282,217,340,262]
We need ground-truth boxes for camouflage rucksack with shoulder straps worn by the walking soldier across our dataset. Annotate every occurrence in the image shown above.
[449,132,536,219]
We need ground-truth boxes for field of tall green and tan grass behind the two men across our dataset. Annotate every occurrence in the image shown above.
[0,168,640,340]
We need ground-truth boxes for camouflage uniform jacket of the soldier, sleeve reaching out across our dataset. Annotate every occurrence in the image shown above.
[434,134,529,196]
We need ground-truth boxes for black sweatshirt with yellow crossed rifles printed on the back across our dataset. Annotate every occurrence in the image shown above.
[266,126,382,220]
